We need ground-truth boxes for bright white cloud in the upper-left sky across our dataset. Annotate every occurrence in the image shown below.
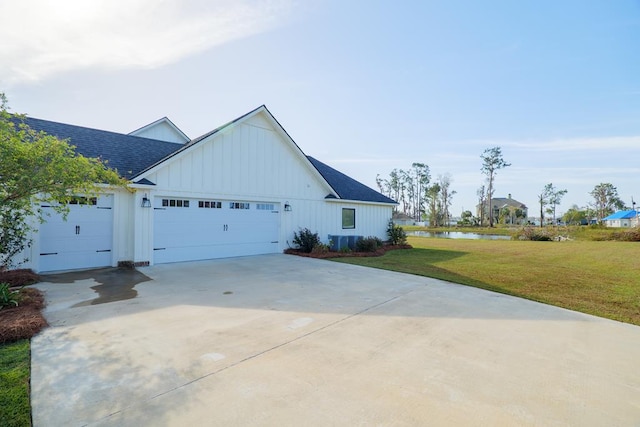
[0,0,291,86]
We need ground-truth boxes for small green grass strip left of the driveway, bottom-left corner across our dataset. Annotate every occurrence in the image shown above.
[0,339,31,427]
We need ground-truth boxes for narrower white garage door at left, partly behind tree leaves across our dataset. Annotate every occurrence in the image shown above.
[39,195,113,271]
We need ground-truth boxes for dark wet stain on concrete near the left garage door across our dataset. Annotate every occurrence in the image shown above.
[41,268,152,307]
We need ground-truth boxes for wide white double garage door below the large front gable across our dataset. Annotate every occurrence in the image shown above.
[153,197,280,264]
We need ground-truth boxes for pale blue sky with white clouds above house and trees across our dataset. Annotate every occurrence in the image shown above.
[0,0,640,216]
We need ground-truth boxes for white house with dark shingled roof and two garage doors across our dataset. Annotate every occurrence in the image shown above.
[16,106,396,272]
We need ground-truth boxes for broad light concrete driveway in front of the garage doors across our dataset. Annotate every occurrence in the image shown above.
[31,255,640,427]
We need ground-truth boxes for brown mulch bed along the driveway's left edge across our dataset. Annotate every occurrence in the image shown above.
[0,270,48,344]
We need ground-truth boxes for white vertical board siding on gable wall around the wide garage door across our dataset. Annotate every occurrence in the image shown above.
[134,114,392,261]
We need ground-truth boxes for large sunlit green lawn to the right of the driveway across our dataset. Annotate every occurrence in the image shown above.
[334,237,640,325]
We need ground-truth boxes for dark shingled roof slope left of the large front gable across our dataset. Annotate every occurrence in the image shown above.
[25,117,183,179]
